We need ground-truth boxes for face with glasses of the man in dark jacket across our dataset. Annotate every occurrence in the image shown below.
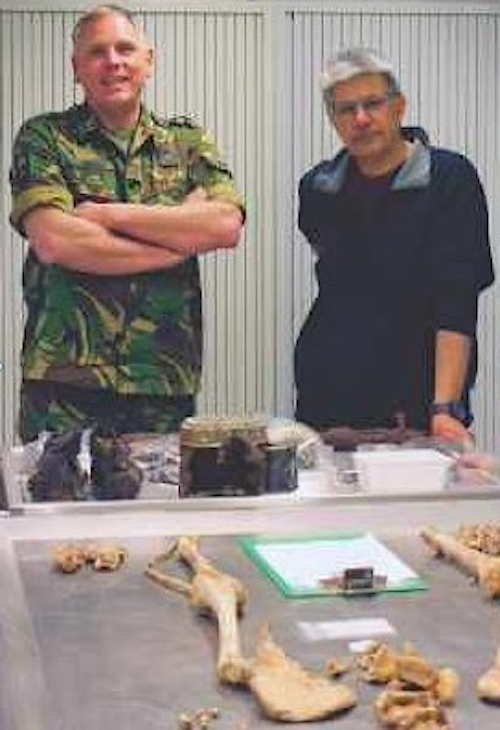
[333,74,406,162]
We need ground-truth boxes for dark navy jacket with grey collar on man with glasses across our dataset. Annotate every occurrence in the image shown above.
[295,129,494,429]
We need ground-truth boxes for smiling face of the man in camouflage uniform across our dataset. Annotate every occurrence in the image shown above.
[73,14,153,121]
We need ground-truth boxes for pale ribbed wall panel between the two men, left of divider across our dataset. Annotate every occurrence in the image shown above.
[139,11,272,413]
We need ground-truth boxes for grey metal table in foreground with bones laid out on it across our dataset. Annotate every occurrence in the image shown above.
[0,470,500,730]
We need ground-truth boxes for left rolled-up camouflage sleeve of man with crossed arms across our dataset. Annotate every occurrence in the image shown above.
[10,116,73,235]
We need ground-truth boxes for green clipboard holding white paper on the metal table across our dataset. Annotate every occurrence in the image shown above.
[238,532,428,598]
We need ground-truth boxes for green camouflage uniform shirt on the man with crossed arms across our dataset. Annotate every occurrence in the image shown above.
[11,104,241,438]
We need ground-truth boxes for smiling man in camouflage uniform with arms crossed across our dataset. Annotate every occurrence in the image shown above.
[7,6,244,441]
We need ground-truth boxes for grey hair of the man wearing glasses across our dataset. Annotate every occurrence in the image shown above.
[321,48,401,117]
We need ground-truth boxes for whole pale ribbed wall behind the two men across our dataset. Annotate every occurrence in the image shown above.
[0,0,500,451]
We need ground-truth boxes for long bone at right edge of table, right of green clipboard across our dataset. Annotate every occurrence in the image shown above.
[421,527,500,598]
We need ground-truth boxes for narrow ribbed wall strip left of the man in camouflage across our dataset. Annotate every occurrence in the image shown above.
[0,11,76,444]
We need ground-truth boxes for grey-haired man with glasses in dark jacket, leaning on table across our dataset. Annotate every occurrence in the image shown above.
[295,49,494,442]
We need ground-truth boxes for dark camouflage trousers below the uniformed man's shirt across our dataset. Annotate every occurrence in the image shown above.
[19,381,194,443]
